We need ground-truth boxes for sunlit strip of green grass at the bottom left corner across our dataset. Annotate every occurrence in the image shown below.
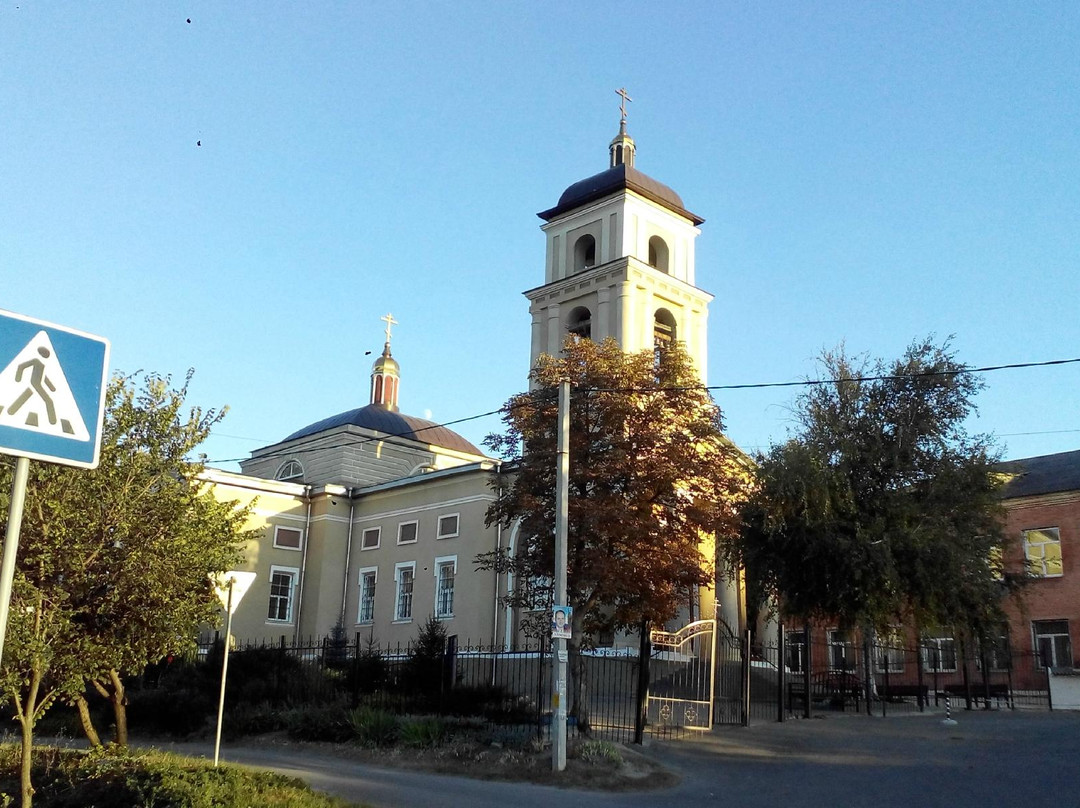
[0,743,349,808]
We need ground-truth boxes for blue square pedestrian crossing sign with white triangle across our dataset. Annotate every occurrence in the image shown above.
[0,310,109,469]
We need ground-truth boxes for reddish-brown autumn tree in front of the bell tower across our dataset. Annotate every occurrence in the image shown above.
[477,337,745,729]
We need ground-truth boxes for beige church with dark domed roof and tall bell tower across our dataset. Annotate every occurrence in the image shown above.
[205,104,744,647]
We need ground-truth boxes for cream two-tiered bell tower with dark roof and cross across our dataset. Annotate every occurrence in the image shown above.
[525,90,713,383]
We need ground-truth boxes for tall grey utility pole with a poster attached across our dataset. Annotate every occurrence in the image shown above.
[551,379,572,771]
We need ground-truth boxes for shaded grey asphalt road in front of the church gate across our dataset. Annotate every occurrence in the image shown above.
[156,711,1080,808]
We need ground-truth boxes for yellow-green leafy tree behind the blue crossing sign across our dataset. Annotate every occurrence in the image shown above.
[0,374,248,805]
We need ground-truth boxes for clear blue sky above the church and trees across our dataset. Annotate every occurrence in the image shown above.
[0,0,1080,469]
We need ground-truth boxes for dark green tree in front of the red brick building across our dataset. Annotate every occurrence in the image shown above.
[732,339,1011,632]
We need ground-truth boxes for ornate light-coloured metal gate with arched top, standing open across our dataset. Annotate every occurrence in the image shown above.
[646,620,716,729]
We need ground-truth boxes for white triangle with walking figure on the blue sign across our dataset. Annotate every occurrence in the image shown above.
[0,331,90,441]
